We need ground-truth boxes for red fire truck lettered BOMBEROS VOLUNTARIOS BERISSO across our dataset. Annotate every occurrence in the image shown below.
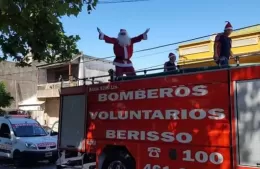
[57,65,260,169]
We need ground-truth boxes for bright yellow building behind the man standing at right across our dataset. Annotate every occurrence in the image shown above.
[178,25,260,68]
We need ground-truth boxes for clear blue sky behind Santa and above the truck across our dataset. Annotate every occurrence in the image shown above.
[62,0,260,69]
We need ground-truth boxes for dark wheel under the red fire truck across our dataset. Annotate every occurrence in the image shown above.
[102,152,135,169]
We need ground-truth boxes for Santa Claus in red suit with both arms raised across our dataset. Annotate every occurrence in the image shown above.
[97,28,150,76]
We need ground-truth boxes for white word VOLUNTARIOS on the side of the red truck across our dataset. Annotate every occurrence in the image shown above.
[89,108,225,120]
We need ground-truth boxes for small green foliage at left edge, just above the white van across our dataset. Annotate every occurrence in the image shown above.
[0,82,14,110]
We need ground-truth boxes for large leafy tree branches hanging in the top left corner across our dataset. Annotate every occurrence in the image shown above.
[0,0,98,66]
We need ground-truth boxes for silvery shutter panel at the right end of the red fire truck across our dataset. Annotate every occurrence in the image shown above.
[236,79,260,167]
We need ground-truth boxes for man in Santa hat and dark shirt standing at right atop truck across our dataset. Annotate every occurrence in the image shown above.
[214,22,233,66]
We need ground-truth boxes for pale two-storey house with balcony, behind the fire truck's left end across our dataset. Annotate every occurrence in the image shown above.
[36,55,114,127]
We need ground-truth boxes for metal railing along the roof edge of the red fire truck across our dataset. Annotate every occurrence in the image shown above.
[59,53,260,87]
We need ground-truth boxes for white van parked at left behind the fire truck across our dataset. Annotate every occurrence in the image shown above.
[0,115,58,166]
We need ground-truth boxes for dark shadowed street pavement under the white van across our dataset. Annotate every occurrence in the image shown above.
[0,160,56,169]
